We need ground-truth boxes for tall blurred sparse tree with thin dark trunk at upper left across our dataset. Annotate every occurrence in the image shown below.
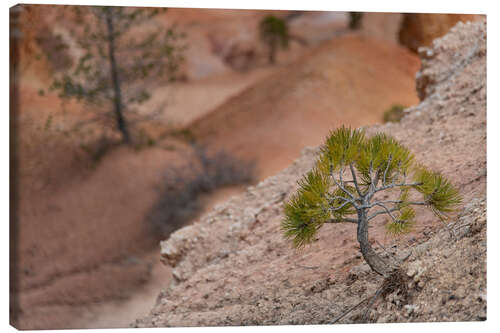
[46,6,184,144]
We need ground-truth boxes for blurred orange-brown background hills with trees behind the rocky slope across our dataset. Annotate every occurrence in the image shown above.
[10,5,480,329]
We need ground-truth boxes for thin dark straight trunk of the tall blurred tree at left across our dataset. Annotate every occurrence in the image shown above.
[106,8,130,144]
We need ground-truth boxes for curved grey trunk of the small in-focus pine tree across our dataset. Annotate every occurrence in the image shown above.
[357,209,397,277]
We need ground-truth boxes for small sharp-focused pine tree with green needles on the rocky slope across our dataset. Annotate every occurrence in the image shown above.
[282,127,461,277]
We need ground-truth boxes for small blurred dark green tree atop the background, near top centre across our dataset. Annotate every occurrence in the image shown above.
[259,15,290,64]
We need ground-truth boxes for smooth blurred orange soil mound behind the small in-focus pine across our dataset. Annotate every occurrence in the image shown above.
[190,35,420,178]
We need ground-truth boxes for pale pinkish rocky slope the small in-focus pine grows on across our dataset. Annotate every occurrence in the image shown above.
[132,22,486,327]
